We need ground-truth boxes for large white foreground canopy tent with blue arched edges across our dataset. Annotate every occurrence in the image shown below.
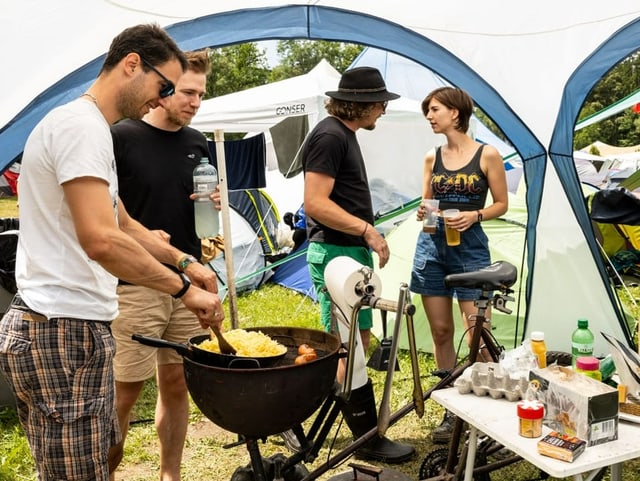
[0,0,640,353]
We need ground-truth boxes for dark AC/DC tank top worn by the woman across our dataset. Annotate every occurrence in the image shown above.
[431,145,489,211]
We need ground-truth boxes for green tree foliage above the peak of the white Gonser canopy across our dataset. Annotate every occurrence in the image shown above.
[269,40,364,82]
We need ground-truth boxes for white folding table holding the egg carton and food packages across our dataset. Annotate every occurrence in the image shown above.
[431,388,640,481]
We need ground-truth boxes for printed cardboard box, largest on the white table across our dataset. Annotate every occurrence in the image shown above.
[529,366,618,446]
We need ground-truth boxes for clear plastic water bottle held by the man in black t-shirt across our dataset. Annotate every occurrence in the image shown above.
[193,157,220,239]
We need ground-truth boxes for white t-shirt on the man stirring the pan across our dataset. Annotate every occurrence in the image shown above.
[16,99,118,321]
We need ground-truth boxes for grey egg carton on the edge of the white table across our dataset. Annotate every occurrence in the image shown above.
[453,362,529,401]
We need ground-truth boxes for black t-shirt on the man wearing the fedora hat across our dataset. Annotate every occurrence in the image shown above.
[302,117,374,247]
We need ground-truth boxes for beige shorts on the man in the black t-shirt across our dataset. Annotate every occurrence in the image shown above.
[111,285,208,382]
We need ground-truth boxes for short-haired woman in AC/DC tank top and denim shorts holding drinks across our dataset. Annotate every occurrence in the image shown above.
[410,87,508,442]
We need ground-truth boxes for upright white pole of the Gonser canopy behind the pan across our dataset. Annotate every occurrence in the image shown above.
[213,130,239,329]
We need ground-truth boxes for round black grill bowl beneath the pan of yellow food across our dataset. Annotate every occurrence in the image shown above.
[184,327,340,438]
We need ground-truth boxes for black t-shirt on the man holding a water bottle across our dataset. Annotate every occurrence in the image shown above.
[111,120,209,267]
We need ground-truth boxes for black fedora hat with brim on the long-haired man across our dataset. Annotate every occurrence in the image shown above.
[325,67,400,102]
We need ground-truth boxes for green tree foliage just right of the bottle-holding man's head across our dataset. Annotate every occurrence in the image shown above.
[205,42,270,98]
